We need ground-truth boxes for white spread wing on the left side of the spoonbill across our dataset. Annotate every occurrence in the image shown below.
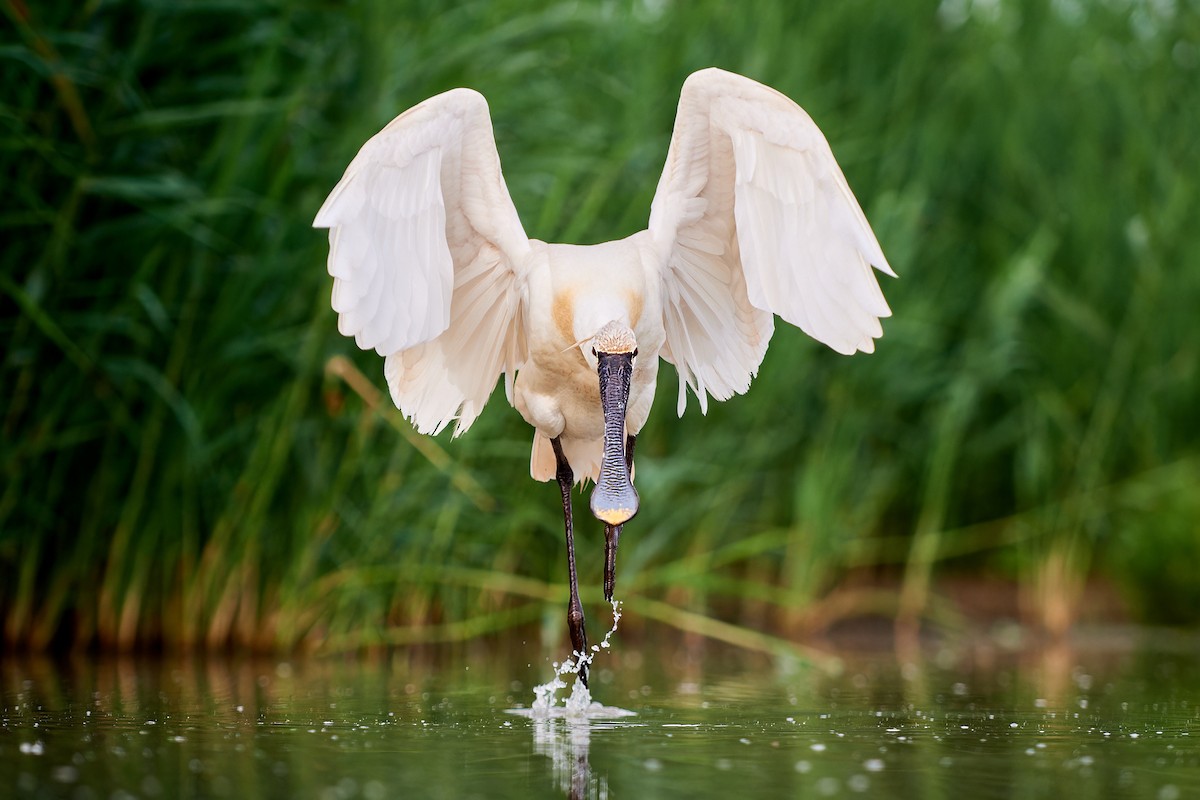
[313,89,529,435]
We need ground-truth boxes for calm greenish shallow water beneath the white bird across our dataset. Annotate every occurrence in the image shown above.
[0,644,1200,800]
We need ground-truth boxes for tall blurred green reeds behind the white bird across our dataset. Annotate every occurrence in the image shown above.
[0,0,1200,650]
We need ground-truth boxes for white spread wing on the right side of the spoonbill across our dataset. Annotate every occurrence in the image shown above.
[649,68,895,414]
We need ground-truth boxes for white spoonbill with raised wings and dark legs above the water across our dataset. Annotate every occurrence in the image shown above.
[313,68,895,684]
